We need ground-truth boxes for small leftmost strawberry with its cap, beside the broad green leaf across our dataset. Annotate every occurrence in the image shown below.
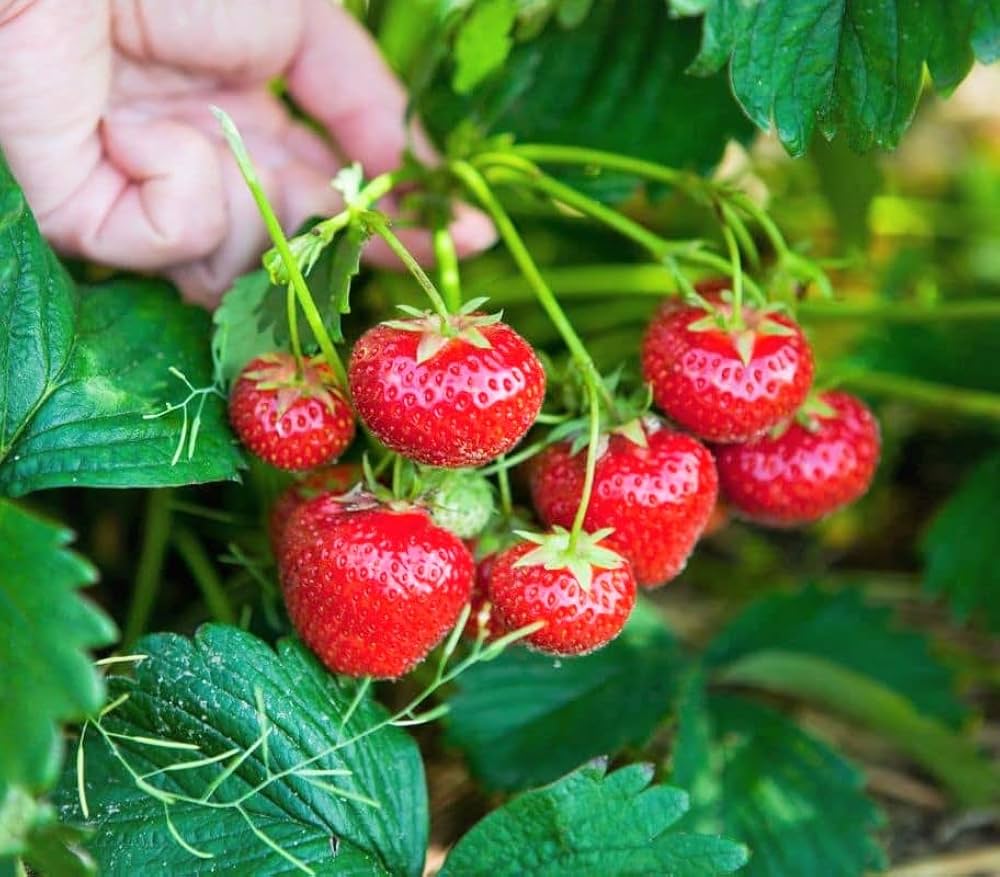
[229,353,354,470]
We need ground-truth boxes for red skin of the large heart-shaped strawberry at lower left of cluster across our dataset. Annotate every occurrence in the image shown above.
[278,497,473,679]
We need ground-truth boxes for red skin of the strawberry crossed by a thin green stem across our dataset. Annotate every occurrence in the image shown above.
[529,418,718,588]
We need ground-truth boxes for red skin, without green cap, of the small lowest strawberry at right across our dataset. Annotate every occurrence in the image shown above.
[490,542,636,656]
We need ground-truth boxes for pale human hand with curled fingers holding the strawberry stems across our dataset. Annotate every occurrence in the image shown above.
[0,0,494,305]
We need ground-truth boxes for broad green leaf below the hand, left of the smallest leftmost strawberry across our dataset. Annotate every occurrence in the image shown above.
[0,278,242,496]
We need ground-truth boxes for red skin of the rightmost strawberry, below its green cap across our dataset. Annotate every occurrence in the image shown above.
[715,391,880,527]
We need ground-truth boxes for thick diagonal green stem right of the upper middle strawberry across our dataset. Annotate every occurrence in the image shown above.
[452,161,615,412]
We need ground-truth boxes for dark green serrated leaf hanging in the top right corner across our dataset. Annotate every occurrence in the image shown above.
[692,0,1000,155]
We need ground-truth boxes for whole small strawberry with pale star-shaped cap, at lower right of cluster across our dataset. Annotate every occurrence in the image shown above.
[490,528,636,655]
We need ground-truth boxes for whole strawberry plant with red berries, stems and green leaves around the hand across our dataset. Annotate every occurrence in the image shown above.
[0,0,1000,877]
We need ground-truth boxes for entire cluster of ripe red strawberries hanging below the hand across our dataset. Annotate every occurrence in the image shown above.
[230,290,879,678]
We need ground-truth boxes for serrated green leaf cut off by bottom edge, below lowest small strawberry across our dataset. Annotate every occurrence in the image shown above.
[441,761,748,877]
